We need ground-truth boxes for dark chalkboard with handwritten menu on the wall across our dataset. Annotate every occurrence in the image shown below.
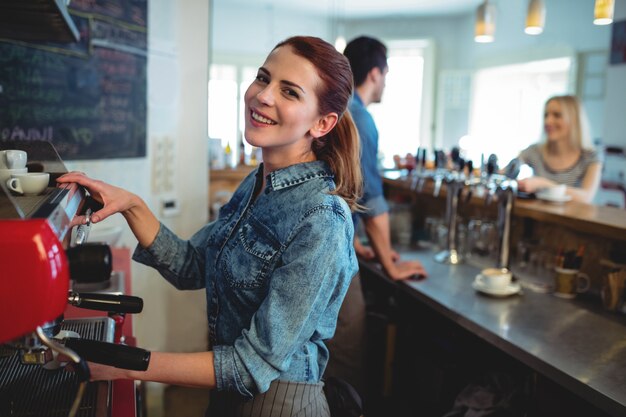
[0,0,147,160]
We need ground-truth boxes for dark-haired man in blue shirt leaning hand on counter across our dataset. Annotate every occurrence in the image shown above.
[325,36,425,404]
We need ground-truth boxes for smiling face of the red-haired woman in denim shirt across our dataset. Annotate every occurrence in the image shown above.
[244,45,322,159]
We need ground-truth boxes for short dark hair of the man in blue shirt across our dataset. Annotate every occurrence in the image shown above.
[343,36,387,87]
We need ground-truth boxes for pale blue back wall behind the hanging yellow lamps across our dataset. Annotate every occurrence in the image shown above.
[344,0,608,148]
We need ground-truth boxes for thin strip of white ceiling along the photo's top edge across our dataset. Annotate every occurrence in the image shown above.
[214,0,482,18]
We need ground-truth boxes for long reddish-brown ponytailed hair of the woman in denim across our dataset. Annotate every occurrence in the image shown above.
[274,36,363,211]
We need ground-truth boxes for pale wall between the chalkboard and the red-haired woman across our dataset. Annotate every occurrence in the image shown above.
[67,0,209,351]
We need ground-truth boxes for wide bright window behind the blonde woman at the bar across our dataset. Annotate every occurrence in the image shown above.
[459,57,572,167]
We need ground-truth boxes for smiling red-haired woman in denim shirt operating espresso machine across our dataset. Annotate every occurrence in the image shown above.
[58,37,361,417]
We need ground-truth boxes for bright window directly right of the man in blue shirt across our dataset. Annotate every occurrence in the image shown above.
[368,40,433,168]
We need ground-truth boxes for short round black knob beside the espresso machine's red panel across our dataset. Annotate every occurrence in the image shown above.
[66,243,113,283]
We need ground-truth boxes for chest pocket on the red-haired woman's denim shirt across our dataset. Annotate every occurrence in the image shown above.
[218,215,281,289]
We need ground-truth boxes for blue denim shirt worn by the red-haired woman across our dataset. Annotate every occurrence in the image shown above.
[133,161,358,397]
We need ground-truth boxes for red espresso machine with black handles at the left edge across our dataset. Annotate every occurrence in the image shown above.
[0,142,150,417]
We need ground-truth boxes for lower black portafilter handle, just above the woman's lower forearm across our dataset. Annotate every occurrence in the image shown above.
[63,337,151,371]
